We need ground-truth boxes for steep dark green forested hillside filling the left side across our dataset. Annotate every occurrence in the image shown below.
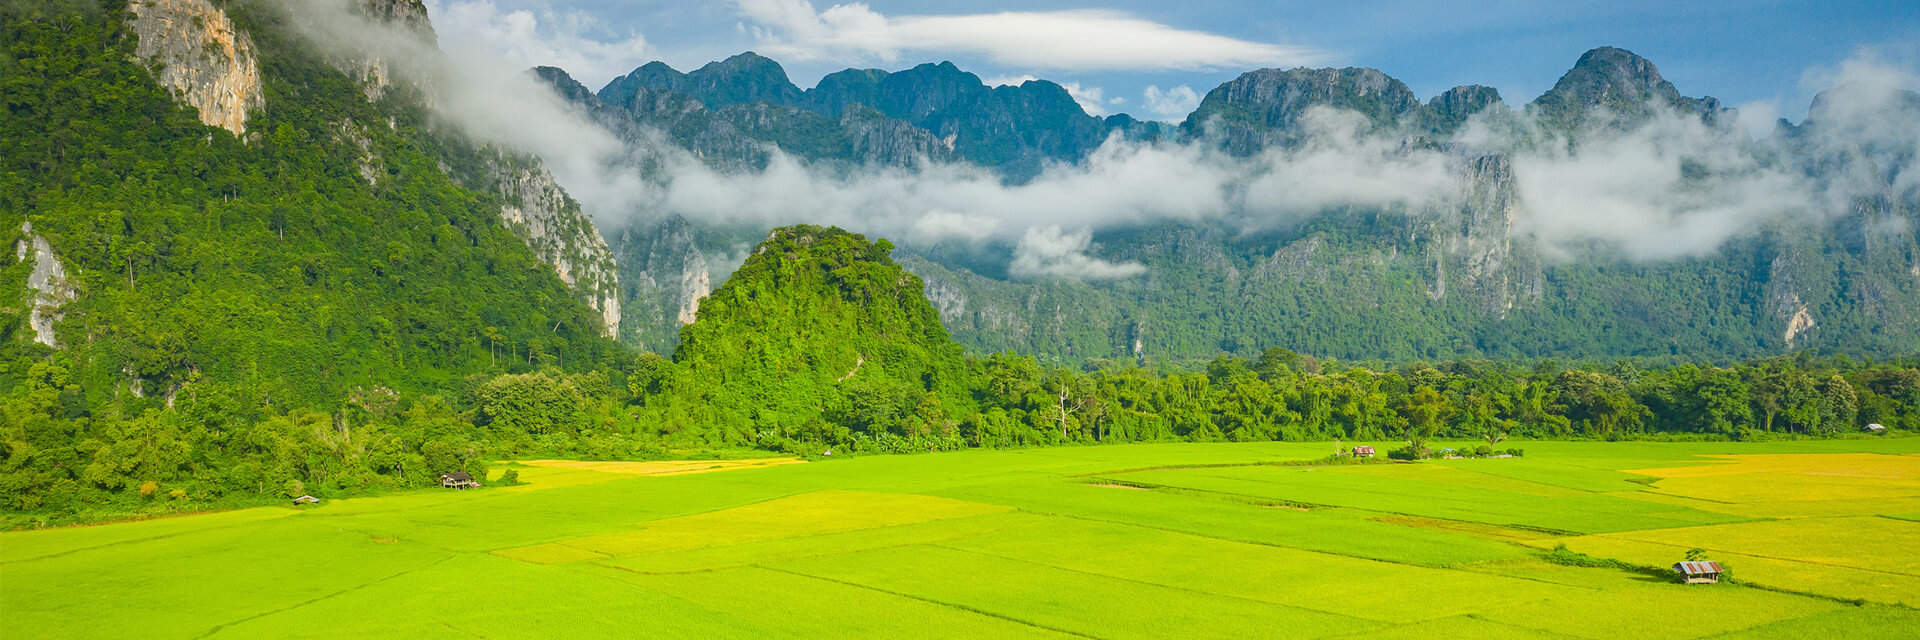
[0,0,624,511]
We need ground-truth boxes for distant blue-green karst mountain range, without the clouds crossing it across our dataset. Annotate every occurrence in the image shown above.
[541,48,1920,359]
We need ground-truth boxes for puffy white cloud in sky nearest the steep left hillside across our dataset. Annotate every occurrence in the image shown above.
[426,0,655,86]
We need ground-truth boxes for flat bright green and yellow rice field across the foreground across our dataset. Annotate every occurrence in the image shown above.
[0,438,1920,640]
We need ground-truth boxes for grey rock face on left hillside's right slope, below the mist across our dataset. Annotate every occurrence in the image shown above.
[490,154,622,336]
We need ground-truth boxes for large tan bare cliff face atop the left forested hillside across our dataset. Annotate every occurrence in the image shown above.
[127,0,267,135]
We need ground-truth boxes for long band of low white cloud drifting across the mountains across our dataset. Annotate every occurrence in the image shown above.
[278,0,1920,279]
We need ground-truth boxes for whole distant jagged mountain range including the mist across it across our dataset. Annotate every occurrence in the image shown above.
[274,1,1920,359]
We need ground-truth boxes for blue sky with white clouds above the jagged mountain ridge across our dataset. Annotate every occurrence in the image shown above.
[428,0,1920,121]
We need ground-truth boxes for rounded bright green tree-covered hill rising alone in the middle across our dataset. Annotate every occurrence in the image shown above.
[674,225,968,434]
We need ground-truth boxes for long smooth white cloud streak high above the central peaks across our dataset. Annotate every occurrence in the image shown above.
[733,0,1323,71]
